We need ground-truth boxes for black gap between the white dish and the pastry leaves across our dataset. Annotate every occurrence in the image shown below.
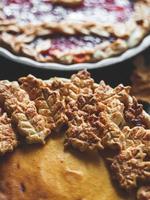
[0,48,150,86]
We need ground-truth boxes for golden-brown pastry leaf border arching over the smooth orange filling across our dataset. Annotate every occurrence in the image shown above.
[0,71,150,198]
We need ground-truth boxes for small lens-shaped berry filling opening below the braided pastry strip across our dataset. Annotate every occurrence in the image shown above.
[39,36,115,60]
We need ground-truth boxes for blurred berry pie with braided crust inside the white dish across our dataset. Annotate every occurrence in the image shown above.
[0,0,150,64]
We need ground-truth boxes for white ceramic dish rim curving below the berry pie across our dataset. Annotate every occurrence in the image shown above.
[0,35,150,71]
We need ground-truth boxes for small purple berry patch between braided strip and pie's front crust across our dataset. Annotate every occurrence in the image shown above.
[35,35,115,59]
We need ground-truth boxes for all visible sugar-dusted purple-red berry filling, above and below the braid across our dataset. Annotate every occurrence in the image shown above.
[2,0,133,62]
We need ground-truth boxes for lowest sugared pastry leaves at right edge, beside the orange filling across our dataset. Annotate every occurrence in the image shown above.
[111,127,150,189]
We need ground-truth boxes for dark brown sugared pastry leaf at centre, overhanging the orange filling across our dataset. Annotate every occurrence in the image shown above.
[66,95,103,151]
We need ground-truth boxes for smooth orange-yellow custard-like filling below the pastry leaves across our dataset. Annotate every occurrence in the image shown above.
[0,136,125,200]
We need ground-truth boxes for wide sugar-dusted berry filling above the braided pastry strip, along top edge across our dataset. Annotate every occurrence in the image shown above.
[2,0,133,23]
